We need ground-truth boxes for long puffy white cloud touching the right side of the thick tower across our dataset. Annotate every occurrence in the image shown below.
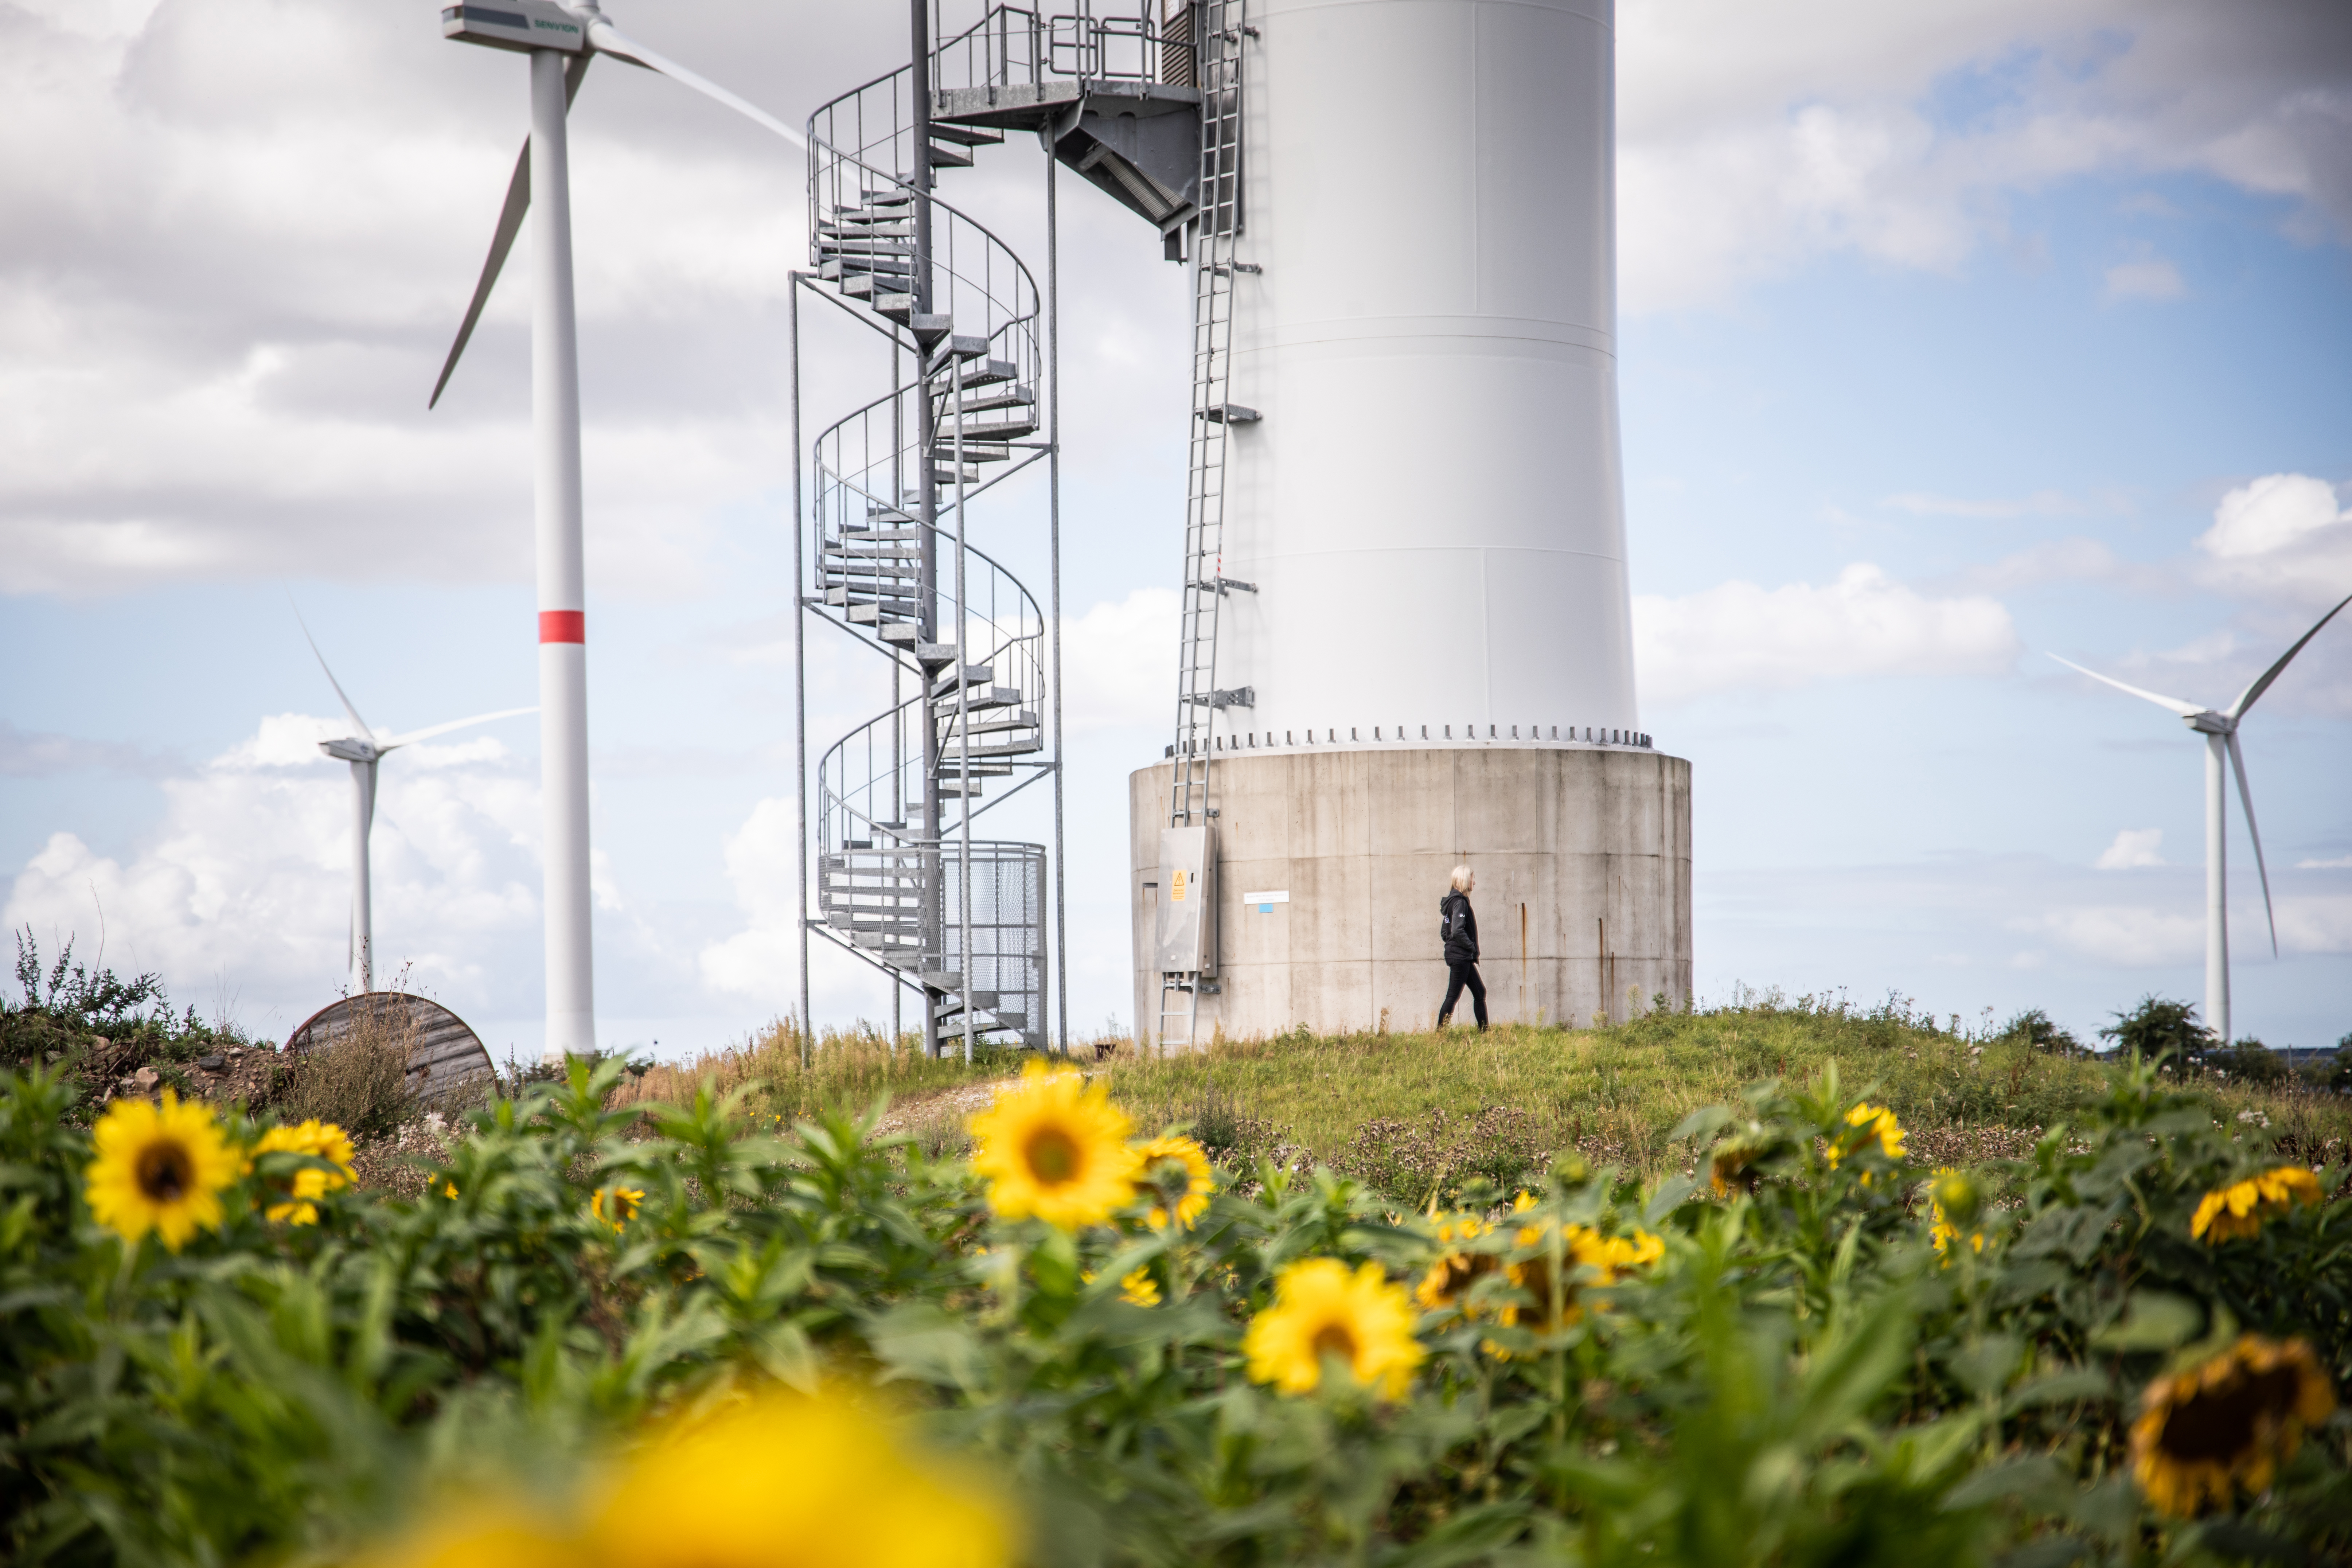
[1632,562,2018,703]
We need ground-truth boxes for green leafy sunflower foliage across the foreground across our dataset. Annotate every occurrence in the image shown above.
[0,1062,2352,1568]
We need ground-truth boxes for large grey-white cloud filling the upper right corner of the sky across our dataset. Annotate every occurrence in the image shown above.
[1618,0,2352,313]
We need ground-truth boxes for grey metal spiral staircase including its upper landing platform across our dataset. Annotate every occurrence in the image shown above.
[795,0,1228,1051]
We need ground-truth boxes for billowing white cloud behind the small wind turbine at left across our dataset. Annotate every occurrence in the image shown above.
[0,712,541,1034]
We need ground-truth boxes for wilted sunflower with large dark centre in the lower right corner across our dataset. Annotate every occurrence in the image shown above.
[2131,1333,2336,1519]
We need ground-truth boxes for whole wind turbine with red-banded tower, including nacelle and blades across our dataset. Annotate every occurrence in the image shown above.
[428,0,809,1058]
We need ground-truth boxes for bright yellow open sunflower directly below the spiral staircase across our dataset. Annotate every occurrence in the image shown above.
[971,1062,1143,1229]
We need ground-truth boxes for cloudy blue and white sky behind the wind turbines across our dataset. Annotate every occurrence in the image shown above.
[0,0,2352,1053]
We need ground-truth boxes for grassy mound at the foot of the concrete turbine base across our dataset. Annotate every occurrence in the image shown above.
[637,997,2352,1192]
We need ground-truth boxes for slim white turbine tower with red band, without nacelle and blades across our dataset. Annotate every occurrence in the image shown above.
[531,49,595,1058]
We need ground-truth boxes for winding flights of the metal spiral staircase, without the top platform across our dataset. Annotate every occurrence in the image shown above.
[807,9,1051,1051]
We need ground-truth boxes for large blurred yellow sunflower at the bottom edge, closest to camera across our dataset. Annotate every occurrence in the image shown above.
[578,1392,1014,1568]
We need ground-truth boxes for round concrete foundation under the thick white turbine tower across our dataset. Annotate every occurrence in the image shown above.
[1127,741,1691,1041]
